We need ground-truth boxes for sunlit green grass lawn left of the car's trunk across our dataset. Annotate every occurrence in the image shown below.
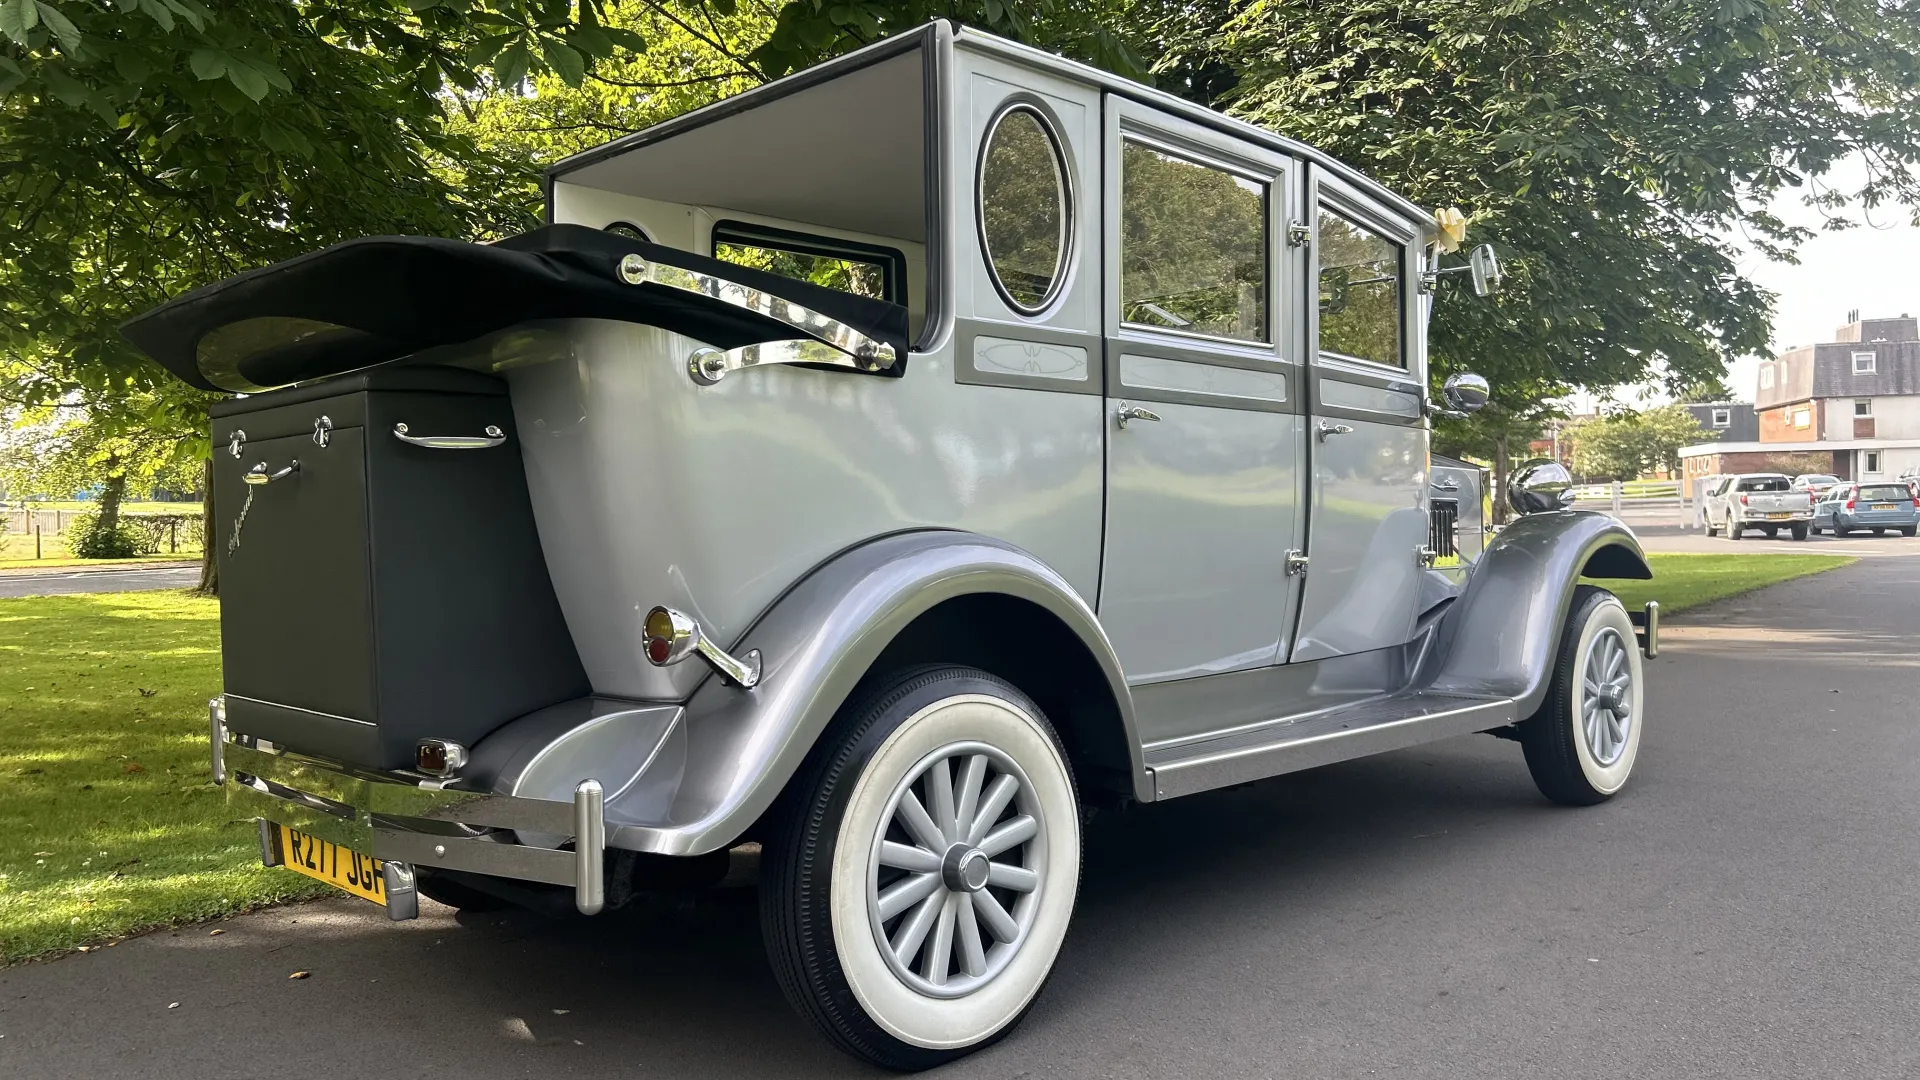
[0,592,326,963]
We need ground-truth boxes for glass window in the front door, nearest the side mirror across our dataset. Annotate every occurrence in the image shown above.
[1319,208,1407,367]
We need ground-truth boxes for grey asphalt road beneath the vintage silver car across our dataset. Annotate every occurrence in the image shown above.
[0,559,1920,1080]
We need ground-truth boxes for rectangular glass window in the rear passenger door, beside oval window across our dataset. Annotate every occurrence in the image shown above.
[1119,138,1273,342]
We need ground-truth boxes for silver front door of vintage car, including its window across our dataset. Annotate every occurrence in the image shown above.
[1292,167,1428,661]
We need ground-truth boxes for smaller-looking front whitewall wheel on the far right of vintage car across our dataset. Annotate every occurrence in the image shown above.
[1521,584,1642,807]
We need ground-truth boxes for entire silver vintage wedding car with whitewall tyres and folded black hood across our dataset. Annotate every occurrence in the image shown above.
[125,23,1657,1068]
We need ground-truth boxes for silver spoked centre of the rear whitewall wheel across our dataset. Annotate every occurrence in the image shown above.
[866,742,1046,997]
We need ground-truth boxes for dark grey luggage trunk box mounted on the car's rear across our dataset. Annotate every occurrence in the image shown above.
[207,367,588,769]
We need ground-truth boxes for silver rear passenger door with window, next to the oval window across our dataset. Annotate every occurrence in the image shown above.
[1100,96,1304,687]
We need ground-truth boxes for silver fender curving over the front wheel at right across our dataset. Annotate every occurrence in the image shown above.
[1428,509,1653,717]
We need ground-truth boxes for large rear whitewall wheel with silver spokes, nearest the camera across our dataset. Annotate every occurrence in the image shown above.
[760,667,1081,1070]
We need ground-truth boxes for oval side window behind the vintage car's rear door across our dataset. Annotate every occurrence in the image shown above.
[979,104,1073,315]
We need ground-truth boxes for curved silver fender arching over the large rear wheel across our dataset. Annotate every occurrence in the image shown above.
[609,530,1146,855]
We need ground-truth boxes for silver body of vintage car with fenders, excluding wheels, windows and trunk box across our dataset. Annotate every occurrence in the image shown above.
[215,23,1651,899]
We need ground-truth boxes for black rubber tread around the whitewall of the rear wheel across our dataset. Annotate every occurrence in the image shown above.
[760,667,1079,1072]
